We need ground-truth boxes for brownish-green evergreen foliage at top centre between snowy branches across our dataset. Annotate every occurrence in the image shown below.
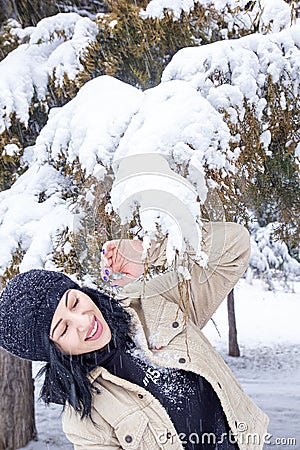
[78,0,218,89]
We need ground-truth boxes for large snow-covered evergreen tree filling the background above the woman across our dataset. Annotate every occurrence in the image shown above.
[0,0,299,446]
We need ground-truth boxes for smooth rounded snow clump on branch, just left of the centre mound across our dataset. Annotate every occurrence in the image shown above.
[25,75,144,175]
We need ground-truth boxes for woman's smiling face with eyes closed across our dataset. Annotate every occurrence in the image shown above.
[50,289,111,355]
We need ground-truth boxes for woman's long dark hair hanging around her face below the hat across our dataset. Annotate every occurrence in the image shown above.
[37,287,131,418]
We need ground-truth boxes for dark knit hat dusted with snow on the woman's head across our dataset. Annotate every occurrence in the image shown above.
[0,269,80,361]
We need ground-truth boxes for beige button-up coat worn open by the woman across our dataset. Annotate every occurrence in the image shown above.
[63,223,268,450]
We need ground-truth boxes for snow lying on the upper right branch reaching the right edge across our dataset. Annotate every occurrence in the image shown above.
[162,25,300,161]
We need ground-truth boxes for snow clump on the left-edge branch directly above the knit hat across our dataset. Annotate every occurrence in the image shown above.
[0,164,73,275]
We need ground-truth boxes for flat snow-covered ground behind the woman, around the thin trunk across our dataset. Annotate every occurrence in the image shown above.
[20,280,300,450]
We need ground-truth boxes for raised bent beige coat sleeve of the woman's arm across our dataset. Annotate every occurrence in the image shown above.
[142,222,250,328]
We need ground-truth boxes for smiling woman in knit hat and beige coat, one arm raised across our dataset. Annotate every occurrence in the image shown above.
[0,223,268,450]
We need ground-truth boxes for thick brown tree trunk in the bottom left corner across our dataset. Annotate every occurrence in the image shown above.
[0,350,36,450]
